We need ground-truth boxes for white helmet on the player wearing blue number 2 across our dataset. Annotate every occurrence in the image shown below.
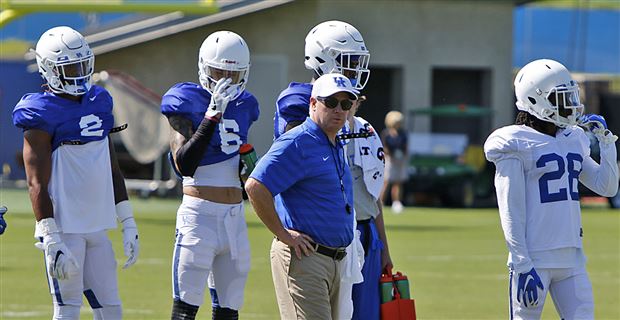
[34,27,95,96]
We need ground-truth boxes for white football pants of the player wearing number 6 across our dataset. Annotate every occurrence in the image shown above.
[172,195,250,310]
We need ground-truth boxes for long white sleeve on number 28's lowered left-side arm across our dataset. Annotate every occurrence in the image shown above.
[495,158,534,273]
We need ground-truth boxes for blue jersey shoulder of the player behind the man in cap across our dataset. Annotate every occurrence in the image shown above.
[273,82,312,140]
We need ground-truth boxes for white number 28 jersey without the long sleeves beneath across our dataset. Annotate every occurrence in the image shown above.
[485,125,590,252]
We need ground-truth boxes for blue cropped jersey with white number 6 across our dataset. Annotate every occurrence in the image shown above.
[161,82,259,166]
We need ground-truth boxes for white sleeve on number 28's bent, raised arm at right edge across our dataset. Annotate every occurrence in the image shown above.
[579,143,618,197]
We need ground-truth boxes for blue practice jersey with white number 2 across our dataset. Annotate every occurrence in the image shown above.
[13,86,114,151]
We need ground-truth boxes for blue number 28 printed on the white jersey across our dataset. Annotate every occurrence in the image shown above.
[536,153,583,203]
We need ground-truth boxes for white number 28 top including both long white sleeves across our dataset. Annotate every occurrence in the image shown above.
[484,125,618,272]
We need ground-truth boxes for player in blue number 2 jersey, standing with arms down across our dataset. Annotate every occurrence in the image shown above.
[13,27,139,319]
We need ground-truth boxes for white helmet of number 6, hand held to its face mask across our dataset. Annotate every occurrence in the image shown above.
[198,31,250,100]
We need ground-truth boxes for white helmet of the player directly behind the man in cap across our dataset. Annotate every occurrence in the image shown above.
[305,20,370,90]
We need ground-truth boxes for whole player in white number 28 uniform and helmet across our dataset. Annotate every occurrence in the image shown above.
[484,59,618,319]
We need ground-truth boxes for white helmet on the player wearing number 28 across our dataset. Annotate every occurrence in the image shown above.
[514,59,584,128]
